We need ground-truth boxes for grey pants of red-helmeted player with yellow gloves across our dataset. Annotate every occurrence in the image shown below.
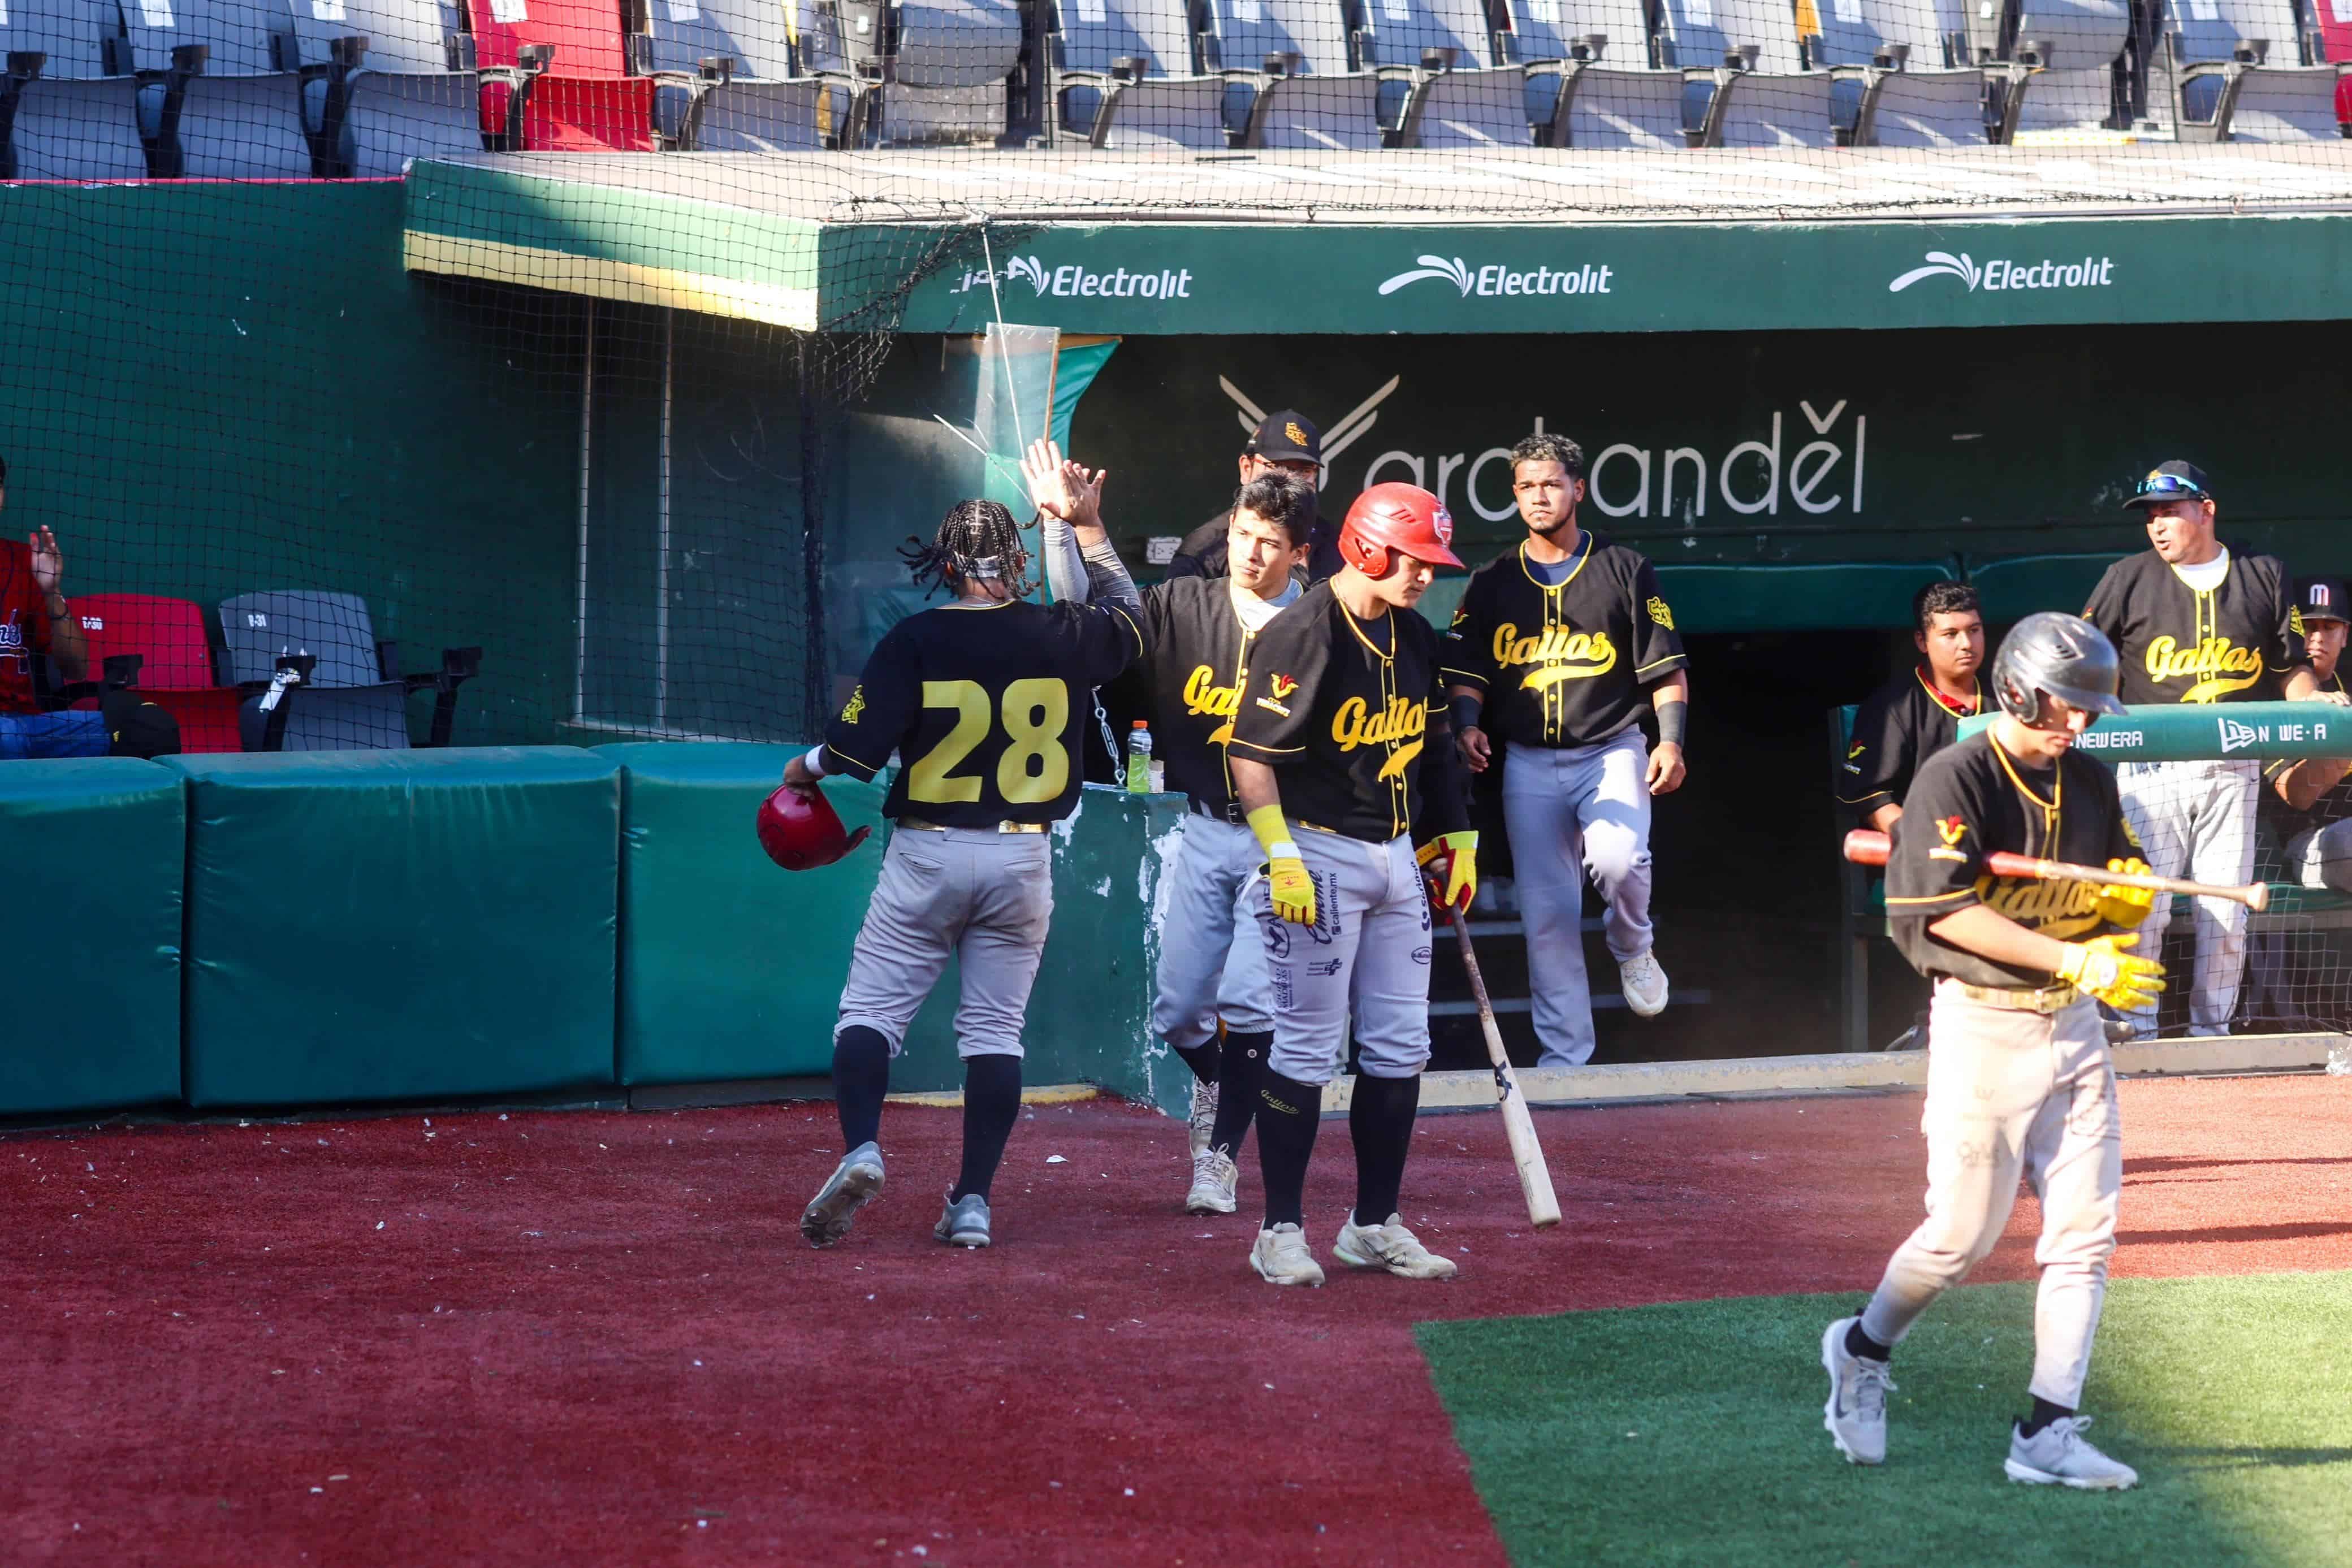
[1251,823,1430,1089]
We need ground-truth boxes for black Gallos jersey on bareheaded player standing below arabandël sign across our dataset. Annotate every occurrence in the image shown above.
[1444,529,1691,748]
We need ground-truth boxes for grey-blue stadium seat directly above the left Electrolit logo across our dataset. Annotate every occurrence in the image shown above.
[1047,0,1230,150]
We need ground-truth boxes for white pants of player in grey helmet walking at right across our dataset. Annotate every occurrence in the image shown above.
[1863,980,2124,1410]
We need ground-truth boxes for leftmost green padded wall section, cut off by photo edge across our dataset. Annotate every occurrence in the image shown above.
[0,757,186,1114]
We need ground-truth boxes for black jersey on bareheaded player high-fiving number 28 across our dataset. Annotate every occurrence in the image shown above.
[1136,576,1289,813]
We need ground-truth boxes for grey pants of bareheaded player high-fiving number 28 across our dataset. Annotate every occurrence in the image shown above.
[1152,811,1275,1049]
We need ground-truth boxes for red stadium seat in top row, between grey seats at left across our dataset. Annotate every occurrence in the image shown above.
[466,0,654,153]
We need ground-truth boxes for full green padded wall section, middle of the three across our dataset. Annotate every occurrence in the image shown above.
[170,745,621,1105]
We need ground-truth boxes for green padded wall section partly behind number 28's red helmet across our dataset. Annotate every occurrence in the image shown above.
[598,743,882,1084]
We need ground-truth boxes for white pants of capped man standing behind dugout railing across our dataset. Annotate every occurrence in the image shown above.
[2115,759,2263,1039]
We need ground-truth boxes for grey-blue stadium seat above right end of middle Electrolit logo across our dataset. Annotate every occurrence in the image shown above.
[1510,0,1689,148]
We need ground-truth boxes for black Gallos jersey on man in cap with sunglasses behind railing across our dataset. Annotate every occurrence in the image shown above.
[2082,550,2307,703]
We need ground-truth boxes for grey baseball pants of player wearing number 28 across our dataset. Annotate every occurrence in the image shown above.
[833,825,1054,1055]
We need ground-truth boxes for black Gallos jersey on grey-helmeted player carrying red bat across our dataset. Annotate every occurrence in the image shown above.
[1886,729,2152,990]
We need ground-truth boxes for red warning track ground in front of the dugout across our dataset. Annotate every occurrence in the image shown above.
[0,1077,2352,1568]
